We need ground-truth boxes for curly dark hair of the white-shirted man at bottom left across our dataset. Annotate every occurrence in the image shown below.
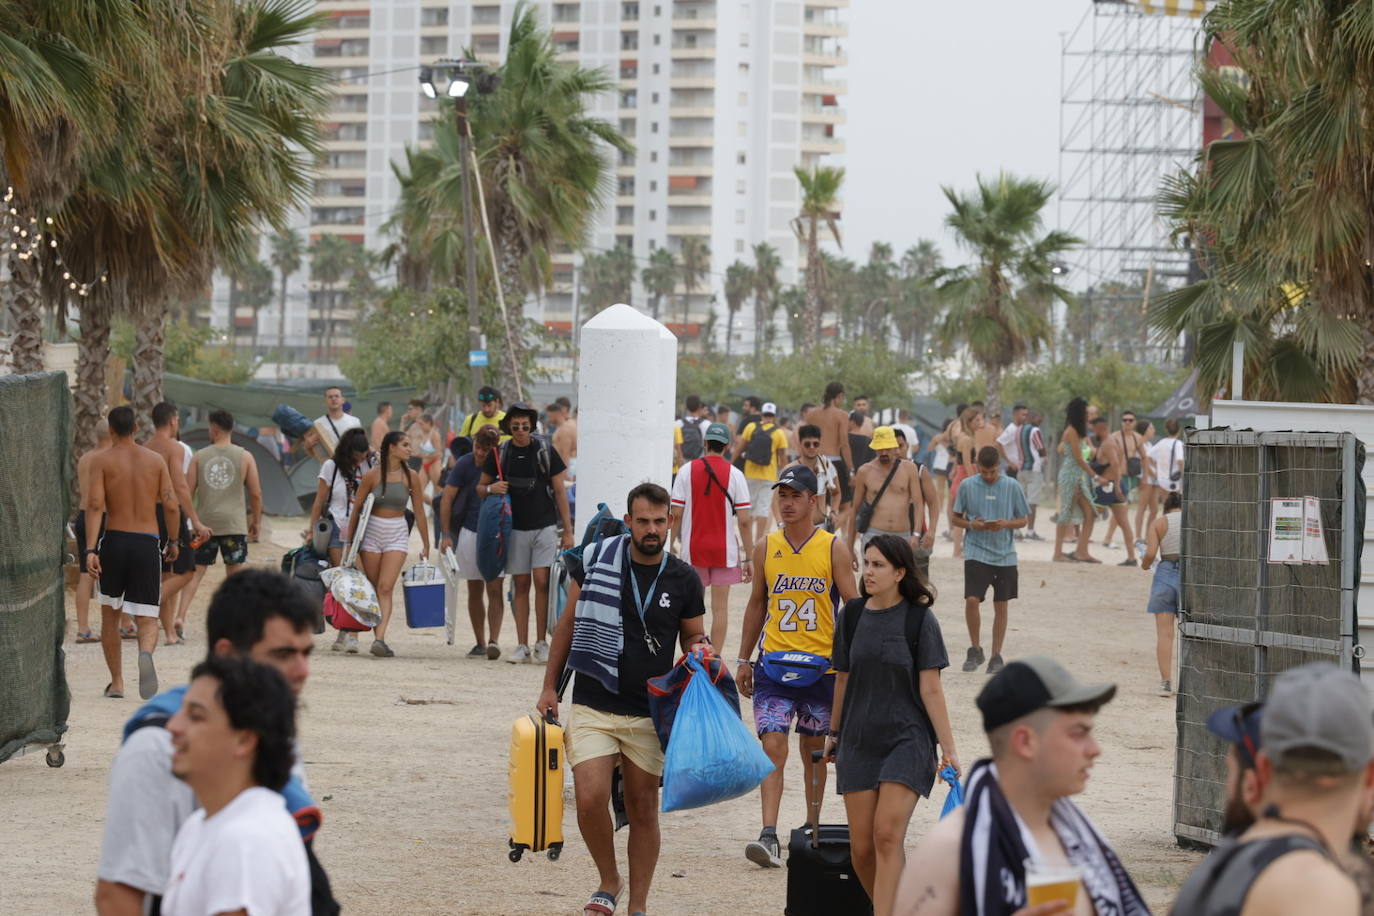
[191,655,295,792]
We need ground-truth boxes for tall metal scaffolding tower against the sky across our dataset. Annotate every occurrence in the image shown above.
[1058,0,1205,357]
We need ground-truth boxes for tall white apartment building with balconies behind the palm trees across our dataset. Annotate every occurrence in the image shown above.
[221,0,849,376]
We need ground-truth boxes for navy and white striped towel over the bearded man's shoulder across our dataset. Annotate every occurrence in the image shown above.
[567,534,629,694]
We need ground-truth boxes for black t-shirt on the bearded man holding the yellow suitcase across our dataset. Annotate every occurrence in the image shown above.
[567,555,706,717]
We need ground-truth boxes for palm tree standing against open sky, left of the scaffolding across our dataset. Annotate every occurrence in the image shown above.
[936,173,1080,413]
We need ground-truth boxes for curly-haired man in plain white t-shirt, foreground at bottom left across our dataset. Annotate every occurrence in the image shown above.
[162,655,311,916]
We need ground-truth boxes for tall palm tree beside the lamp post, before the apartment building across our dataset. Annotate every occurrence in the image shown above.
[464,0,633,398]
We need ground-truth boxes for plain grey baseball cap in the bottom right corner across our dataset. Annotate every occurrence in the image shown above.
[1260,662,1374,772]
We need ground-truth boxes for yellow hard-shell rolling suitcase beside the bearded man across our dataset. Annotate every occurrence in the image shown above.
[510,713,563,862]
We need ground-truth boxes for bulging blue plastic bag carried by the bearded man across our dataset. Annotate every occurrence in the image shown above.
[662,655,774,812]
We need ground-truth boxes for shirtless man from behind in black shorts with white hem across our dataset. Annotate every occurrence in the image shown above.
[87,407,181,699]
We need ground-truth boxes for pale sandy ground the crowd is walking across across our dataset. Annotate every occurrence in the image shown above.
[0,519,1197,915]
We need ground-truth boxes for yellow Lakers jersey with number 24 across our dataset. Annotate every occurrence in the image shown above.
[758,527,838,658]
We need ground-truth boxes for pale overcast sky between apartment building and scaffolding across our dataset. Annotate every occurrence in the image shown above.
[840,0,1090,264]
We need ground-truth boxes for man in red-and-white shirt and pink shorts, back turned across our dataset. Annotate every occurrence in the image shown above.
[671,423,753,645]
